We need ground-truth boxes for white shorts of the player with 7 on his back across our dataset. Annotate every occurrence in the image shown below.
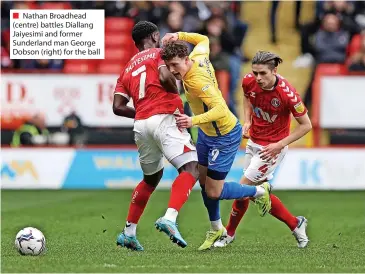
[133,114,198,175]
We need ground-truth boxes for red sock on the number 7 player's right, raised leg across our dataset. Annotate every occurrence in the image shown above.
[168,171,196,211]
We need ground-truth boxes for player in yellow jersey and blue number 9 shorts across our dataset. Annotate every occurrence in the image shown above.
[161,32,271,250]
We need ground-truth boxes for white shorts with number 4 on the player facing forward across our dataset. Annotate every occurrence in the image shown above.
[243,140,288,183]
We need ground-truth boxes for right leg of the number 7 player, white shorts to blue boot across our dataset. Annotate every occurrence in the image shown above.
[151,115,198,247]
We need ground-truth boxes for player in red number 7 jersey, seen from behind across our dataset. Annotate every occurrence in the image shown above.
[113,21,199,251]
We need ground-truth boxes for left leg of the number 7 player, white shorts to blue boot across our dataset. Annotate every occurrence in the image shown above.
[117,120,163,251]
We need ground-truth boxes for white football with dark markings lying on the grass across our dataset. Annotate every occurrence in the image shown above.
[15,227,46,256]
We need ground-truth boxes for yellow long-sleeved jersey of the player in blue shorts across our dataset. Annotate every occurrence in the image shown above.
[178,32,237,136]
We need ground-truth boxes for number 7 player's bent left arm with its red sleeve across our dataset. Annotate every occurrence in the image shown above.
[113,76,136,119]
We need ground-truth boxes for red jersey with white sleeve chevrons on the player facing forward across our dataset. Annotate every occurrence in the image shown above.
[242,73,307,146]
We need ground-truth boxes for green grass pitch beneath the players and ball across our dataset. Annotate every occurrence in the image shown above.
[1,190,365,273]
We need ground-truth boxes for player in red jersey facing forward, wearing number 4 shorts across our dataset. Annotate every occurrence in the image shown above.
[214,51,312,248]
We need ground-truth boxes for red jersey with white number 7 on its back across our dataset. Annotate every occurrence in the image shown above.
[114,48,183,120]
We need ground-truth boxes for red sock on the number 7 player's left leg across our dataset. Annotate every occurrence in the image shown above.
[127,181,155,224]
